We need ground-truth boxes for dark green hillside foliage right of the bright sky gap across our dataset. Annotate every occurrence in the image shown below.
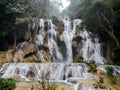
[66,0,120,47]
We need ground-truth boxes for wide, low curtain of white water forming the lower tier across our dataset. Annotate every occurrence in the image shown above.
[0,63,93,81]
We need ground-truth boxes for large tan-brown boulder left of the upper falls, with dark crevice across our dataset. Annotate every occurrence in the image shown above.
[13,42,36,62]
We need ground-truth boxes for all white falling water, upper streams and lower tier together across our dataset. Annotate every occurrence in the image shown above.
[0,19,108,90]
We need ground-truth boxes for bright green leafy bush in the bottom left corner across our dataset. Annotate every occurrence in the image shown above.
[0,78,16,90]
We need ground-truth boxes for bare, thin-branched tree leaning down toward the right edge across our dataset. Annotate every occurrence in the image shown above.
[98,0,120,47]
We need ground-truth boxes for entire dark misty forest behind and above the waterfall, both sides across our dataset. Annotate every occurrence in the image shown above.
[0,0,120,64]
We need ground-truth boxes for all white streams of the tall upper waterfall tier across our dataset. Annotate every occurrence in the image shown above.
[36,19,105,64]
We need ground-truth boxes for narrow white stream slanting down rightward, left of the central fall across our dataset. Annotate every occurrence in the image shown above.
[48,20,63,62]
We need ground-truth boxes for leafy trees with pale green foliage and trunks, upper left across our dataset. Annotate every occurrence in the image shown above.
[0,0,50,48]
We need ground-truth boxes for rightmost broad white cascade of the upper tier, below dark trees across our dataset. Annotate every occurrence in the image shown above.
[80,29,105,64]
